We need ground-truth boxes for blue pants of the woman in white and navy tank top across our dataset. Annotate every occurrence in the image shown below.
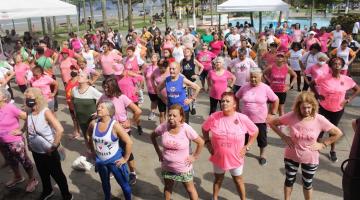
[96,163,131,200]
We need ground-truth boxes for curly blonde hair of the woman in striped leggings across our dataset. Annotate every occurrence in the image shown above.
[293,91,319,118]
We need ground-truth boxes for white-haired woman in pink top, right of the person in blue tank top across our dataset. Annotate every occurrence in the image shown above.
[208,57,236,115]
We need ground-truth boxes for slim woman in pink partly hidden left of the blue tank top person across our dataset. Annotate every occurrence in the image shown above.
[143,53,159,120]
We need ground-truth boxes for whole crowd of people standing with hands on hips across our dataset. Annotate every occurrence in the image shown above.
[0,18,360,200]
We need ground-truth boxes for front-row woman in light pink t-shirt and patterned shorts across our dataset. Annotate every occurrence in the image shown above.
[151,104,204,200]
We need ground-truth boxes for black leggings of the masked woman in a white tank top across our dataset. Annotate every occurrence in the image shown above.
[32,150,72,200]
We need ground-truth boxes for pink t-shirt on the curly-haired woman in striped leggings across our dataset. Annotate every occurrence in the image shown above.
[280,112,334,164]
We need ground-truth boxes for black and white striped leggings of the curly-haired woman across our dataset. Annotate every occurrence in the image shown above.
[284,158,319,190]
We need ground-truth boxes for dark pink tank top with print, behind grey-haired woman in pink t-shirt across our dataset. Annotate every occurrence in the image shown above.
[270,64,288,92]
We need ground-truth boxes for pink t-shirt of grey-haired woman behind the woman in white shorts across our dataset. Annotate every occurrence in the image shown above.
[235,83,278,123]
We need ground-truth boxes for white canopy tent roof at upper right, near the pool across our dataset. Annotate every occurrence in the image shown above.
[217,0,290,12]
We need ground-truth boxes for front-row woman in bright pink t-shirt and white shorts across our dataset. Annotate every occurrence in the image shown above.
[202,92,258,200]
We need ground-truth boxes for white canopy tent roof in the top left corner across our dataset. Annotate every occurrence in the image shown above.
[0,0,77,20]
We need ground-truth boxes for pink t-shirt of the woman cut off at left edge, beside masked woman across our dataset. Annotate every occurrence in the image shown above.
[0,103,22,143]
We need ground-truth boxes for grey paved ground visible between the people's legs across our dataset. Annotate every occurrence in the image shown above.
[0,72,360,200]
